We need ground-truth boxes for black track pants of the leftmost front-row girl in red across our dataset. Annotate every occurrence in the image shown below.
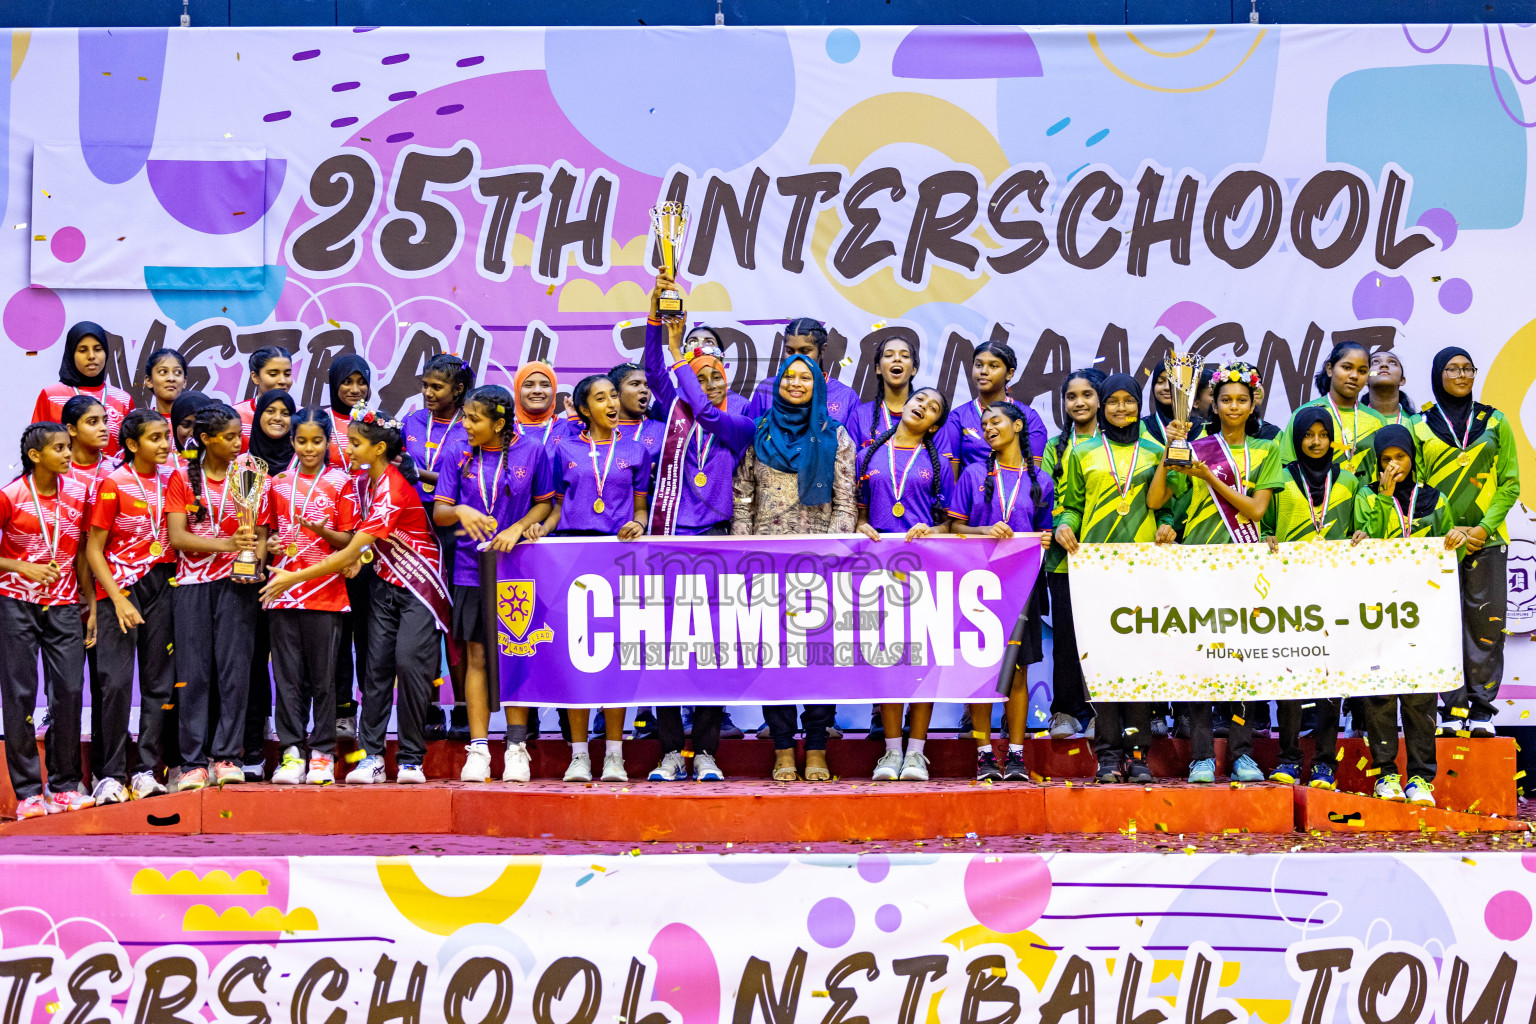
[0,597,86,800]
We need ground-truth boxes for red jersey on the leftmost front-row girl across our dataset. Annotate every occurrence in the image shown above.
[0,476,88,605]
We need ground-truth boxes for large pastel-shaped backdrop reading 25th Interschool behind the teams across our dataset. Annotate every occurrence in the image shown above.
[0,25,1536,721]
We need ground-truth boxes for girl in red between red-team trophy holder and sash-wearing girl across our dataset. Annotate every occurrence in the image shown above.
[267,408,358,786]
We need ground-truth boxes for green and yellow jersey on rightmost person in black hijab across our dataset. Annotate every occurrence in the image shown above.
[1413,405,1521,543]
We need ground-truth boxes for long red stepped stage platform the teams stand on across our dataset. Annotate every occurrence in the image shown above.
[0,738,1527,843]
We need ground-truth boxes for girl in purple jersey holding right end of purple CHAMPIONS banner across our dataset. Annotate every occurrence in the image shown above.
[949,402,1055,781]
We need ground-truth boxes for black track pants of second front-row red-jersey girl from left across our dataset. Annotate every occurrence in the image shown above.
[91,562,181,783]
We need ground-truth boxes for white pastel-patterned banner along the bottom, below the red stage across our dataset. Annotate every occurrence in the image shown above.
[0,849,1536,1024]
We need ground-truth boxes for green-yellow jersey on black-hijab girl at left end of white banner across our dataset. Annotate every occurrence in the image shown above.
[1055,428,1174,543]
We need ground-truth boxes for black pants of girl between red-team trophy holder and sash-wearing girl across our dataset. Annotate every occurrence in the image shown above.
[269,608,343,754]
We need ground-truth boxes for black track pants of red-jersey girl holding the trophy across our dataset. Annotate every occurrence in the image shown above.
[175,579,260,768]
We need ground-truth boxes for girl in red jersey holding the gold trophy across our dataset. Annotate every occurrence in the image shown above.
[166,402,267,792]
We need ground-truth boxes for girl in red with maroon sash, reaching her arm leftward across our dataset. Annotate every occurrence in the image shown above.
[261,408,452,783]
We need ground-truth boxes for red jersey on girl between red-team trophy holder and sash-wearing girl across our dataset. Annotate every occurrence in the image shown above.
[266,467,358,611]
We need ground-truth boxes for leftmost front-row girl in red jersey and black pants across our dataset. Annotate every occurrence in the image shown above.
[0,422,95,818]
